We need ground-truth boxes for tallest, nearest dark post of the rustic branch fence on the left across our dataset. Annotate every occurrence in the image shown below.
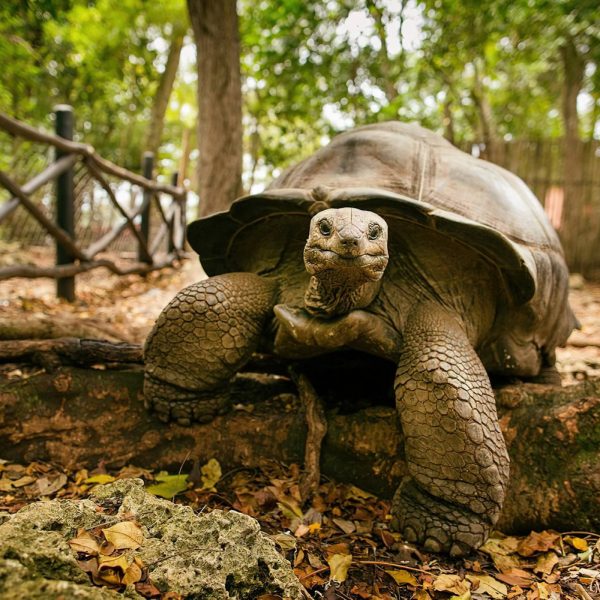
[54,104,75,302]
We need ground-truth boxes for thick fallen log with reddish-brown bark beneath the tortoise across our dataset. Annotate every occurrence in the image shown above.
[0,340,600,532]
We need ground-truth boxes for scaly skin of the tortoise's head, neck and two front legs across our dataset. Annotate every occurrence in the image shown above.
[144,208,509,555]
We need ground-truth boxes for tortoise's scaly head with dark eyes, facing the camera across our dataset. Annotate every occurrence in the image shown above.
[304,207,389,283]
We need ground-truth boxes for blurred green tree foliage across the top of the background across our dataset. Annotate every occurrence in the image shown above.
[0,0,600,189]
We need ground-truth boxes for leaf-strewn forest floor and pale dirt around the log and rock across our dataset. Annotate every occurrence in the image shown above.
[0,251,600,600]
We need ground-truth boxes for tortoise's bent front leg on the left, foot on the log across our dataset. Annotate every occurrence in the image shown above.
[144,273,277,425]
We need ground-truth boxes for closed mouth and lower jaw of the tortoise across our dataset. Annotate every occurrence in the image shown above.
[304,247,389,281]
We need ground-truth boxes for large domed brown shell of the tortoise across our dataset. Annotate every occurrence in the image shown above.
[188,122,576,364]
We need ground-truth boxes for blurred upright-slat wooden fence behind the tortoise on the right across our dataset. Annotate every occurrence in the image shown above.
[463,139,600,279]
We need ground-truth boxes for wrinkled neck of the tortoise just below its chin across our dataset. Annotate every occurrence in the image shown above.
[304,275,381,318]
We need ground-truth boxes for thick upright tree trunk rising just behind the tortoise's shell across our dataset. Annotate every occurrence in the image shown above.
[188,0,242,215]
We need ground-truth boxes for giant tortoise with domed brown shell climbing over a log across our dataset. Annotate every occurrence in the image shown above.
[144,122,575,555]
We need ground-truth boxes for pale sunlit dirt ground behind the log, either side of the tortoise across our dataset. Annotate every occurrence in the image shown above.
[0,249,600,384]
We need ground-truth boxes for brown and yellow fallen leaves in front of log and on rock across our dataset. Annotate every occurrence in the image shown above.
[0,459,600,600]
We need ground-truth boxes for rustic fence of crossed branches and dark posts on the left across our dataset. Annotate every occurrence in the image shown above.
[0,106,186,301]
